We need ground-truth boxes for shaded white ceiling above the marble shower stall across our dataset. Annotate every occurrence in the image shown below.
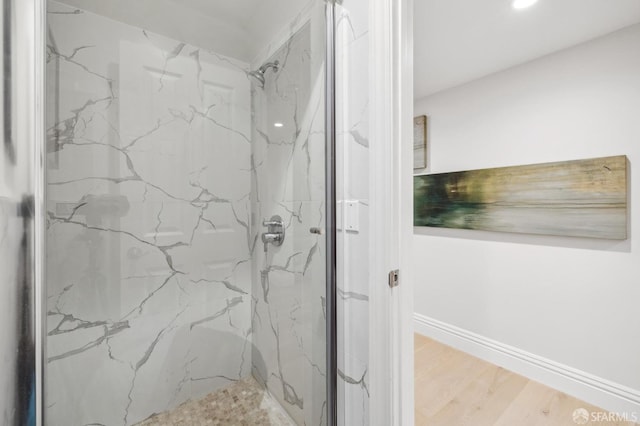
[58,0,308,62]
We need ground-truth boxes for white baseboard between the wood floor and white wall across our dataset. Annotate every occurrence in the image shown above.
[413,313,640,415]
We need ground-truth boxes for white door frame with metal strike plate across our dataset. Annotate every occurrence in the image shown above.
[369,0,414,426]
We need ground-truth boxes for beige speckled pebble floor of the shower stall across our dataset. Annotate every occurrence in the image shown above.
[137,377,295,426]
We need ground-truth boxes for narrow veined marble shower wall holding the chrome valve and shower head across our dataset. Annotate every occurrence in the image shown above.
[252,1,327,425]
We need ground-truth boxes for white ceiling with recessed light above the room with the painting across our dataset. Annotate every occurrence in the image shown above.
[414,0,640,98]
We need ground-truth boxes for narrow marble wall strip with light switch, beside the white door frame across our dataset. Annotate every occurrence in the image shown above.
[336,0,371,426]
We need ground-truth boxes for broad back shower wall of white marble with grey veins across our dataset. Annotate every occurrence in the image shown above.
[46,2,254,426]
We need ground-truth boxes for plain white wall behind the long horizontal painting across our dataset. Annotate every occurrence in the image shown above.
[413,25,640,402]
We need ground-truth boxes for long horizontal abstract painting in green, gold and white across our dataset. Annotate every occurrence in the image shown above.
[414,155,628,240]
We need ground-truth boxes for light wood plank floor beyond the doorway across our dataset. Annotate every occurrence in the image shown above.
[414,334,640,426]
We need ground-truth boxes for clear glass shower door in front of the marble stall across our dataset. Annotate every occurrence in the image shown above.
[45,0,328,425]
